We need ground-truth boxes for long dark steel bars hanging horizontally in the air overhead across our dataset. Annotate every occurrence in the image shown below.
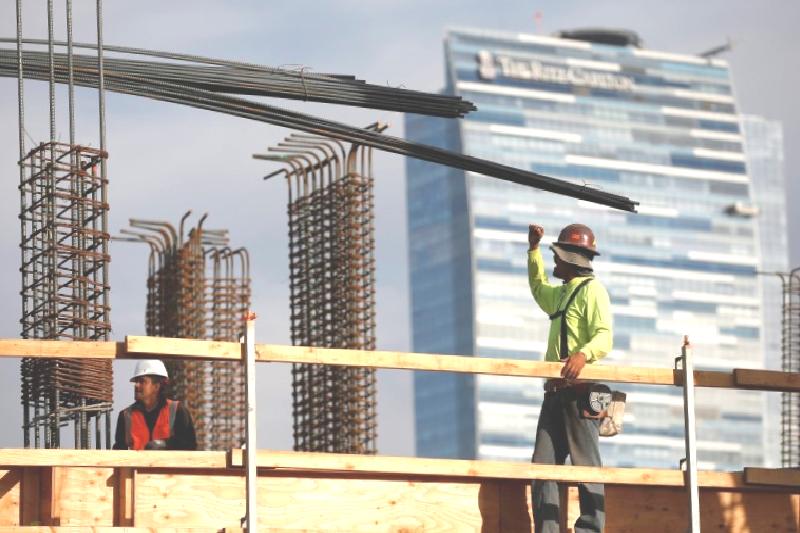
[0,39,636,211]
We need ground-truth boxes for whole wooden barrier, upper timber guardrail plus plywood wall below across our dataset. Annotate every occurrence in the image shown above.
[0,337,800,533]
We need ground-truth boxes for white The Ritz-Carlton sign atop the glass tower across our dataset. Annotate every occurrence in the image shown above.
[478,51,634,91]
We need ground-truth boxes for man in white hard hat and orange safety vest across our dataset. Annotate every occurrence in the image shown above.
[114,359,197,450]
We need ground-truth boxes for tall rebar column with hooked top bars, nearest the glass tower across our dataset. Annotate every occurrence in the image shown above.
[254,124,384,454]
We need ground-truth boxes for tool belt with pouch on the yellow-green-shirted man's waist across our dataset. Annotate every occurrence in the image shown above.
[544,378,626,437]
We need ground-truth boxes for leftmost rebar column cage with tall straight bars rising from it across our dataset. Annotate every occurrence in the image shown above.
[19,142,113,448]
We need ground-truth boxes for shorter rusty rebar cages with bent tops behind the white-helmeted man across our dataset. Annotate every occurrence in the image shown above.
[115,212,250,450]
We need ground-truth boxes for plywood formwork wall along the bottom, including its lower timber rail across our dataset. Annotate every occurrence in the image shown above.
[0,450,800,533]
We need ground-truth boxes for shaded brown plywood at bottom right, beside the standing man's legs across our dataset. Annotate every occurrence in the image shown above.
[606,486,799,533]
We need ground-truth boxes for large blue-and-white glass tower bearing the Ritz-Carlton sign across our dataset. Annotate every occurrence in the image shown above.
[406,30,766,468]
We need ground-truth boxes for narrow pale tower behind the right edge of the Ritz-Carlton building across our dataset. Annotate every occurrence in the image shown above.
[741,115,790,467]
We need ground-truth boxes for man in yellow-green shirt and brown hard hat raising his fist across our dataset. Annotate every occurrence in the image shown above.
[528,224,612,533]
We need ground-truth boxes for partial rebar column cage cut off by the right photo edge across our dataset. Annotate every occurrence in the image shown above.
[778,268,800,468]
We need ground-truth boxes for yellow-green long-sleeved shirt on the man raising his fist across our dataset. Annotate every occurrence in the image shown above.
[528,248,614,363]
